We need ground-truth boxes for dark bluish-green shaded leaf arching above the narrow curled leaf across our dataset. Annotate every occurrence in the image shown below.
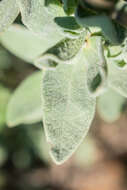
[75,9,118,44]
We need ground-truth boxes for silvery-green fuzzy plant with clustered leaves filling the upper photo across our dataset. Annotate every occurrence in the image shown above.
[0,0,127,164]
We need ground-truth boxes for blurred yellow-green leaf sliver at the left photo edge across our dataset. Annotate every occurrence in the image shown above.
[0,85,10,129]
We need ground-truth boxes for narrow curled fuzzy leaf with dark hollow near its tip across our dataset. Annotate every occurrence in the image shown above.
[84,36,107,96]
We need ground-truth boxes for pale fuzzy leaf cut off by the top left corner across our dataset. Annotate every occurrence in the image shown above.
[0,0,19,32]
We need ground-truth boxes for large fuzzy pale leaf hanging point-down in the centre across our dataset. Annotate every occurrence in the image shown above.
[42,49,96,164]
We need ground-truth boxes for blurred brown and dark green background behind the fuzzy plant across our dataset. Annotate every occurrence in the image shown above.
[0,17,127,190]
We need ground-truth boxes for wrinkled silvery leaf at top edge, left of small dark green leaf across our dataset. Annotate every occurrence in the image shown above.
[17,0,65,36]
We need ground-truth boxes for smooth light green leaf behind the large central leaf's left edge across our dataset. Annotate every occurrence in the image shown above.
[7,72,42,127]
